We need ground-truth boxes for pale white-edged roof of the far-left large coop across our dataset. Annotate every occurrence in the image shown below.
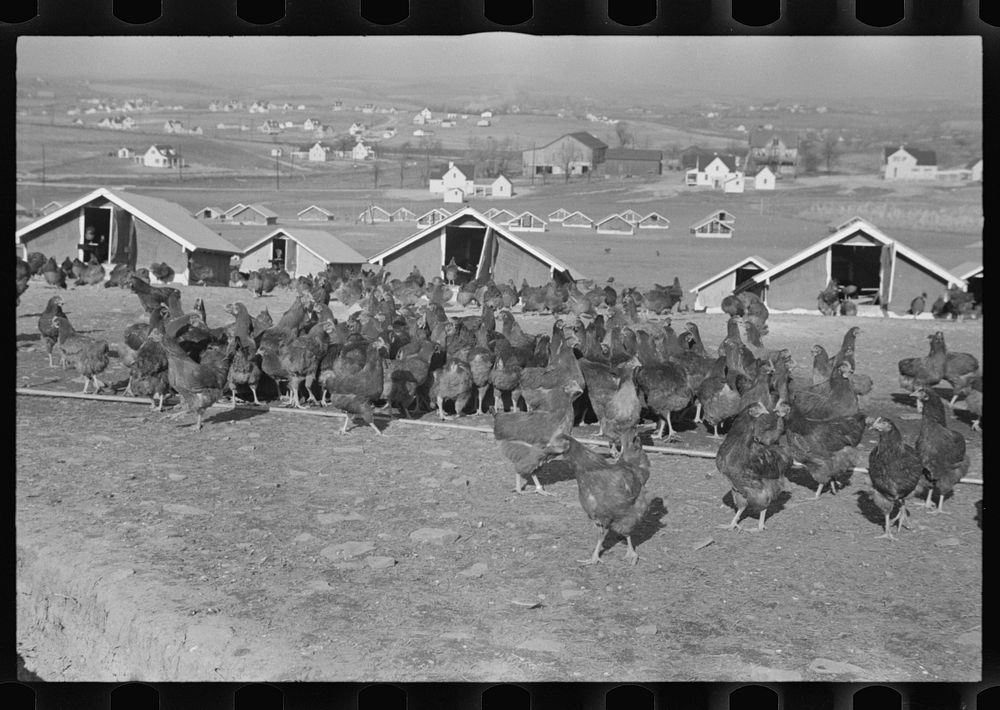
[15,187,240,254]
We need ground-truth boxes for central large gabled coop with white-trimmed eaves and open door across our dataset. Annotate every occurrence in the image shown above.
[369,207,584,284]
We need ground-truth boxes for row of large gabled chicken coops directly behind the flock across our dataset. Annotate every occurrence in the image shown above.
[15,187,983,313]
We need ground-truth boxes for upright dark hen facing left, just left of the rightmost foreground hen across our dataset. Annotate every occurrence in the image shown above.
[868,417,923,540]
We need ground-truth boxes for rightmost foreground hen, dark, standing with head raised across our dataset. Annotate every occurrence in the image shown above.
[913,387,969,513]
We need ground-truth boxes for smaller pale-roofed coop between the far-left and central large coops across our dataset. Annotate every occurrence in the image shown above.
[240,227,368,279]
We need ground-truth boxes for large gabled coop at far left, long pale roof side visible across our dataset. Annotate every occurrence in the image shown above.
[15,187,240,284]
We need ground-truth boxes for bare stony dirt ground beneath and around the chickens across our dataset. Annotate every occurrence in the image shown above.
[16,280,983,682]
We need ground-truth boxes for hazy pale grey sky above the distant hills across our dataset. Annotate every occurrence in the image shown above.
[17,33,982,100]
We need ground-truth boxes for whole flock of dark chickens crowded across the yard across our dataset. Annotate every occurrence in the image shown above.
[19,262,982,564]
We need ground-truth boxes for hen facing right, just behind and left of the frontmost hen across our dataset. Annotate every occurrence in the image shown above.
[493,380,583,495]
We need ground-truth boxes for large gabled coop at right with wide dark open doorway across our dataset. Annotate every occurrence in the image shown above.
[737,218,966,314]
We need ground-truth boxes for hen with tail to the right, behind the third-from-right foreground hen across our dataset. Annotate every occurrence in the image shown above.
[785,403,866,498]
